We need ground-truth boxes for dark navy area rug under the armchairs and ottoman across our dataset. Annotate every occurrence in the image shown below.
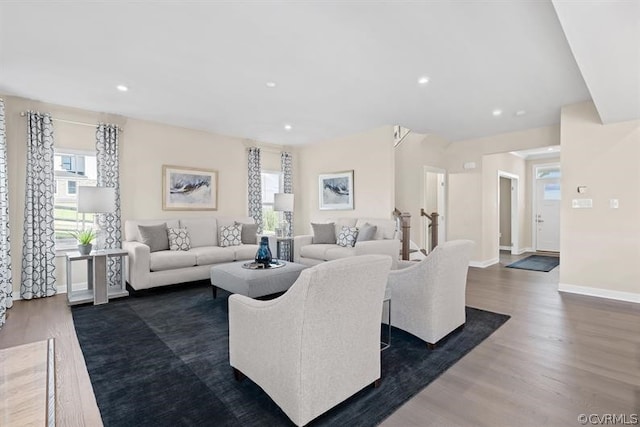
[72,285,509,427]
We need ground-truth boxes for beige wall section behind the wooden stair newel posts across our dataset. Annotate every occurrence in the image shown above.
[394,133,448,248]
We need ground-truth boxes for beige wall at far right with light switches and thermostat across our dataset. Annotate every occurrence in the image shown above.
[560,102,640,302]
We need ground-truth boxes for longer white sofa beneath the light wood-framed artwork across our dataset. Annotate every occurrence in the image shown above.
[122,217,275,290]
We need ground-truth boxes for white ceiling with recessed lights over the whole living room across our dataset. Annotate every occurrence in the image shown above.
[0,0,640,145]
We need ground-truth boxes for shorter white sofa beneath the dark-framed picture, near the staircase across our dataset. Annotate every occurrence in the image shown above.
[293,218,401,269]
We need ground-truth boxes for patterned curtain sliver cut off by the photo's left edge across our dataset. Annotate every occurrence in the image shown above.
[0,99,13,328]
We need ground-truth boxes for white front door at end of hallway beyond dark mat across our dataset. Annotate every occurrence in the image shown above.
[534,179,560,252]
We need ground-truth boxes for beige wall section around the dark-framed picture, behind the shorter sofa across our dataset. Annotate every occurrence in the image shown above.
[294,126,395,234]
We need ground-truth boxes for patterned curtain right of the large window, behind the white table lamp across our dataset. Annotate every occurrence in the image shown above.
[96,123,122,286]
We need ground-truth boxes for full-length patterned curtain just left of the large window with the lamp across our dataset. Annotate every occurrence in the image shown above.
[20,111,56,299]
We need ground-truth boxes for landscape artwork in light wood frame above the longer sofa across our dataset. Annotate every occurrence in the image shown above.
[162,165,218,211]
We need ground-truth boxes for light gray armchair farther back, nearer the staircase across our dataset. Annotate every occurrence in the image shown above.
[383,240,474,348]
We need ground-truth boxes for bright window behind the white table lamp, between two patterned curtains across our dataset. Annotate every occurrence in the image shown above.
[53,149,98,249]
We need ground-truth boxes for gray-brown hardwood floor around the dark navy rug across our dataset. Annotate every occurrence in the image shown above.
[0,253,640,427]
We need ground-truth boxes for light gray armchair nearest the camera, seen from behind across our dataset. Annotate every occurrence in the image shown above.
[229,255,391,425]
